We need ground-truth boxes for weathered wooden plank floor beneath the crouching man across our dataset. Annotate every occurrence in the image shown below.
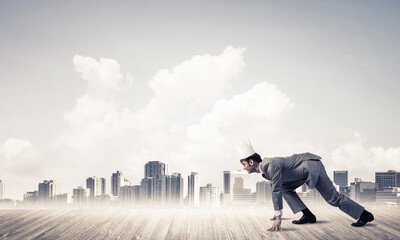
[0,206,400,240]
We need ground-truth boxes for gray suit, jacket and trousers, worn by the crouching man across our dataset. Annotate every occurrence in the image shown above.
[260,153,364,219]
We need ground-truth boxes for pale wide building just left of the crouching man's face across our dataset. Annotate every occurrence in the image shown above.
[224,170,255,203]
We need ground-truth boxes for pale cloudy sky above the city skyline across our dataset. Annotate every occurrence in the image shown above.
[0,0,400,199]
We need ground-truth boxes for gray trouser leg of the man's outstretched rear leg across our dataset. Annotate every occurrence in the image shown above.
[315,163,364,219]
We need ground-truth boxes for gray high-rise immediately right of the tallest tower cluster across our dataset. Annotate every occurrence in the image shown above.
[167,173,183,207]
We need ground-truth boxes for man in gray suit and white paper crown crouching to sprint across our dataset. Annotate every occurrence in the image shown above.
[238,141,374,231]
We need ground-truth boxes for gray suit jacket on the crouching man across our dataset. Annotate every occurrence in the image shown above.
[260,152,321,210]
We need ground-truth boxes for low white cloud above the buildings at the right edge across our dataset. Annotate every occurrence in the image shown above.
[330,133,400,182]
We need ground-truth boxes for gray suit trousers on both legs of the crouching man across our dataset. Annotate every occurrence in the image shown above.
[282,161,364,219]
